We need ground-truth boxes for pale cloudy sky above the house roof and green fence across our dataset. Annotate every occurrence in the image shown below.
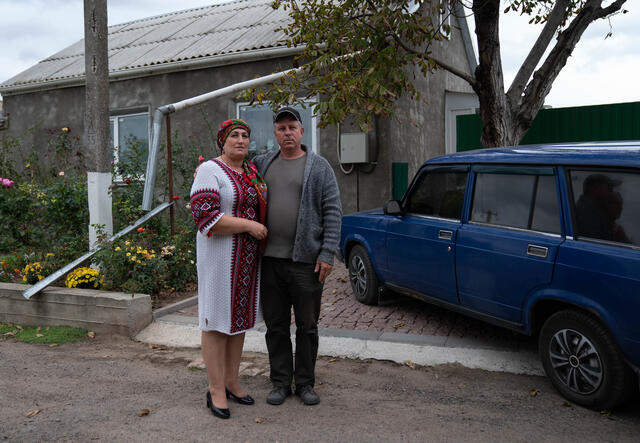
[0,0,640,107]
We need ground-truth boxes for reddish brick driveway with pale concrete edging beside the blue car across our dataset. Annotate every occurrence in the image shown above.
[137,262,543,375]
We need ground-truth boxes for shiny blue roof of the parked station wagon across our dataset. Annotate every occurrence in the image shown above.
[424,141,640,167]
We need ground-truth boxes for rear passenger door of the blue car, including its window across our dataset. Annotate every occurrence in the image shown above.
[456,165,563,323]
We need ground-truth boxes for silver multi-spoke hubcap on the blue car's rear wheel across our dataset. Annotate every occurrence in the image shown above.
[549,329,603,395]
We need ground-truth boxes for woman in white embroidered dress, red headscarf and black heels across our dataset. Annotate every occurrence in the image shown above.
[191,120,267,418]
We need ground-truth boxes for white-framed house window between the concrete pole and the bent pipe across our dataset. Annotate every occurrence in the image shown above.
[109,112,149,180]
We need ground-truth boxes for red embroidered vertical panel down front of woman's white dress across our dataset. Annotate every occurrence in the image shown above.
[214,160,260,333]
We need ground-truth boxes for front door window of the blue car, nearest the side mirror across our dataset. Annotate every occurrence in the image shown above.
[405,169,467,220]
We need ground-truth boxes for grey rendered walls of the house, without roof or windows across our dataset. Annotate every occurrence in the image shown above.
[0,12,471,214]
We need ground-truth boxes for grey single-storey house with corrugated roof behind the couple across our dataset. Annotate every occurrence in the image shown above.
[0,0,477,213]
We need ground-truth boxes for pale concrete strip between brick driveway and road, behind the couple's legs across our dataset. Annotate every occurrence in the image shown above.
[135,314,544,375]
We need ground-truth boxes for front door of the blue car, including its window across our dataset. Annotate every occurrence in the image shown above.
[386,165,469,303]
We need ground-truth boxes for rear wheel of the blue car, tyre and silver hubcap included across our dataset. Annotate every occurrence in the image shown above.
[538,310,637,410]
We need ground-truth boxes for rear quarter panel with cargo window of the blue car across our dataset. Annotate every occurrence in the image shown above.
[554,167,640,350]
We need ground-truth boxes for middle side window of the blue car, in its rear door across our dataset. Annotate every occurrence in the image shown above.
[470,172,560,234]
